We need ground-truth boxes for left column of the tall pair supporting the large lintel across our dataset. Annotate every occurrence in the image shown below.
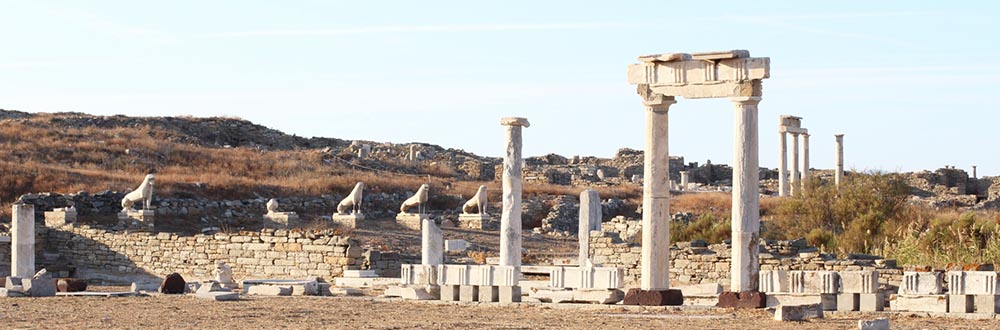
[639,95,677,290]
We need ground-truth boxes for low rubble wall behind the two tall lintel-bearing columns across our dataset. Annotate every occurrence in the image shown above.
[590,217,903,288]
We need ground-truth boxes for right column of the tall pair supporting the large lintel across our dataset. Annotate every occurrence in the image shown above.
[730,97,760,292]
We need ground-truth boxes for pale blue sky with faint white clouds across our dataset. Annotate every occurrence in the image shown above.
[0,0,1000,176]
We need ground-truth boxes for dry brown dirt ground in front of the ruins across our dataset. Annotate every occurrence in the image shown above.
[0,295,1000,330]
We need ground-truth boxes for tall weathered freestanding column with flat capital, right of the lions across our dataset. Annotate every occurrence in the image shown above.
[500,117,530,267]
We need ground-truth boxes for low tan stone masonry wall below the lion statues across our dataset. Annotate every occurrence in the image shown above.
[47,227,363,280]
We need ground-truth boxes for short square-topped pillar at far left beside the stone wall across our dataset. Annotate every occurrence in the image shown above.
[10,202,35,278]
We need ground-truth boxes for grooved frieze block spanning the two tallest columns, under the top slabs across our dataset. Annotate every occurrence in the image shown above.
[628,57,771,86]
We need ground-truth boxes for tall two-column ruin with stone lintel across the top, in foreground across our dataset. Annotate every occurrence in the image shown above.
[624,50,770,305]
